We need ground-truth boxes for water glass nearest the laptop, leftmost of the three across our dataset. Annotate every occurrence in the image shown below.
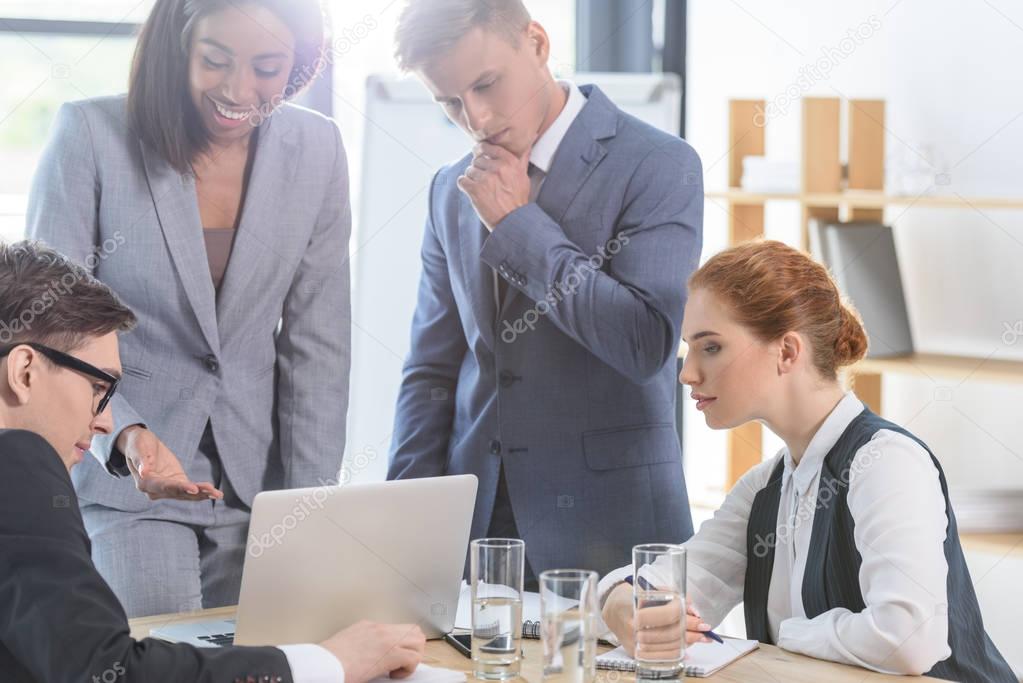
[470,539,526,681]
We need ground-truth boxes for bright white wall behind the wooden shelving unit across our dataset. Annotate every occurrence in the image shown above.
[686,0,1023,490]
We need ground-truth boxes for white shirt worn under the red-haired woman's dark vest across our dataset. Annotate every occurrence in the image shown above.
[599,392,951,674]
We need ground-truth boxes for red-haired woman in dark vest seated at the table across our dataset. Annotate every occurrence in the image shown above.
[601,241,1016,683]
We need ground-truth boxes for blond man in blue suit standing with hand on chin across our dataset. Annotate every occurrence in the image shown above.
[389,0,703,588]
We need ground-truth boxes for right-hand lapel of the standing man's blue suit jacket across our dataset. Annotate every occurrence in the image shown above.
[491,85,618,316]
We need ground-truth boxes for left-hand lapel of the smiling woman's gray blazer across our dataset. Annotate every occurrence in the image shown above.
[141,139,220,353]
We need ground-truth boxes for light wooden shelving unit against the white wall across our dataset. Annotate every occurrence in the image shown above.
[706,97,1023,488]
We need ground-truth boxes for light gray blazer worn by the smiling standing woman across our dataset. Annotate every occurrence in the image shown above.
[28,96,351,511]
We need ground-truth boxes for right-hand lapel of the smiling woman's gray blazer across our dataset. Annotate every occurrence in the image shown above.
[216,117,298,336]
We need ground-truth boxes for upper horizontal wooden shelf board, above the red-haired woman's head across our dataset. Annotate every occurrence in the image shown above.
[706,188,1023,209]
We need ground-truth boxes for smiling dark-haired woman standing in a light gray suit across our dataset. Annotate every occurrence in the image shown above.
[28,0,351,617]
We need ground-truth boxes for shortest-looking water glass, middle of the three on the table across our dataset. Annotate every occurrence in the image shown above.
[540,570,599,683]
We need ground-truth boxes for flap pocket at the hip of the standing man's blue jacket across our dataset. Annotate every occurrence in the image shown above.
[582,422,681,470]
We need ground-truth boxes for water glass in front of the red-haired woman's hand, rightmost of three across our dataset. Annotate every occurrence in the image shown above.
[632,544,685,681]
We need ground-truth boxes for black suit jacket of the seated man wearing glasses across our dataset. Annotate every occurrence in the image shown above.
[0,430,293,683]
